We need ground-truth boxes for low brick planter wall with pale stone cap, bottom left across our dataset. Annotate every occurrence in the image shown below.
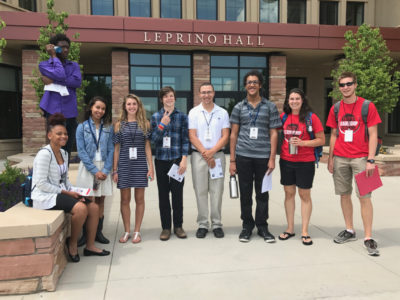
[0,203,70,295]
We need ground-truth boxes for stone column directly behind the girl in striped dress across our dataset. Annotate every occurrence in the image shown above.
[111,50,130,122]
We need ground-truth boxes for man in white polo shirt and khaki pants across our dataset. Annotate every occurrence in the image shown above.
[189,83,230,238]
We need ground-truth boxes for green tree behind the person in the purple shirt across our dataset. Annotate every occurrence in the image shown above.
[30,0,89,110]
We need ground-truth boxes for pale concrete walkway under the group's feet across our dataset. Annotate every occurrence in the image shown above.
[4,157,400,300]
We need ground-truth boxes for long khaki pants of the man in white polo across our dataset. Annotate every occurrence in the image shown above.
[191,152,225,229]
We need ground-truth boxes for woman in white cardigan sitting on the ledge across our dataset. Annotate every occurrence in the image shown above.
[32,113,110,262]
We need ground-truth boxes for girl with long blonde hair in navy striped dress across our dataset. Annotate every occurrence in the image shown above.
[113,94,154,243]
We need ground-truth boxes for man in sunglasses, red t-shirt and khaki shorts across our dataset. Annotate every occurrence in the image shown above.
[326,72,381,256]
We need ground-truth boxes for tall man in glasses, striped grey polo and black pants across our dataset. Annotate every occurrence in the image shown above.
[229,70,282,243]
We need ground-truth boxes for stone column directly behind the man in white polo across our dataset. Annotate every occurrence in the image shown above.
[193,52,211,106]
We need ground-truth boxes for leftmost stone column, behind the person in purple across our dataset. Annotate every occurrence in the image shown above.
[22,49,46,153]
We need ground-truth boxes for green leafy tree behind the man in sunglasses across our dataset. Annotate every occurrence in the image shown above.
[329,24,400,113]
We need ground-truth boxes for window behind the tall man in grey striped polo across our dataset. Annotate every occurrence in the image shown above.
[211,54,268,113]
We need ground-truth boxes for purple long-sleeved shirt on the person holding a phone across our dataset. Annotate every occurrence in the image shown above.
[39,57,82,118]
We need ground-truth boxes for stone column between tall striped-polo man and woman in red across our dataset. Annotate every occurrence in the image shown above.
[269,55,286,112]
